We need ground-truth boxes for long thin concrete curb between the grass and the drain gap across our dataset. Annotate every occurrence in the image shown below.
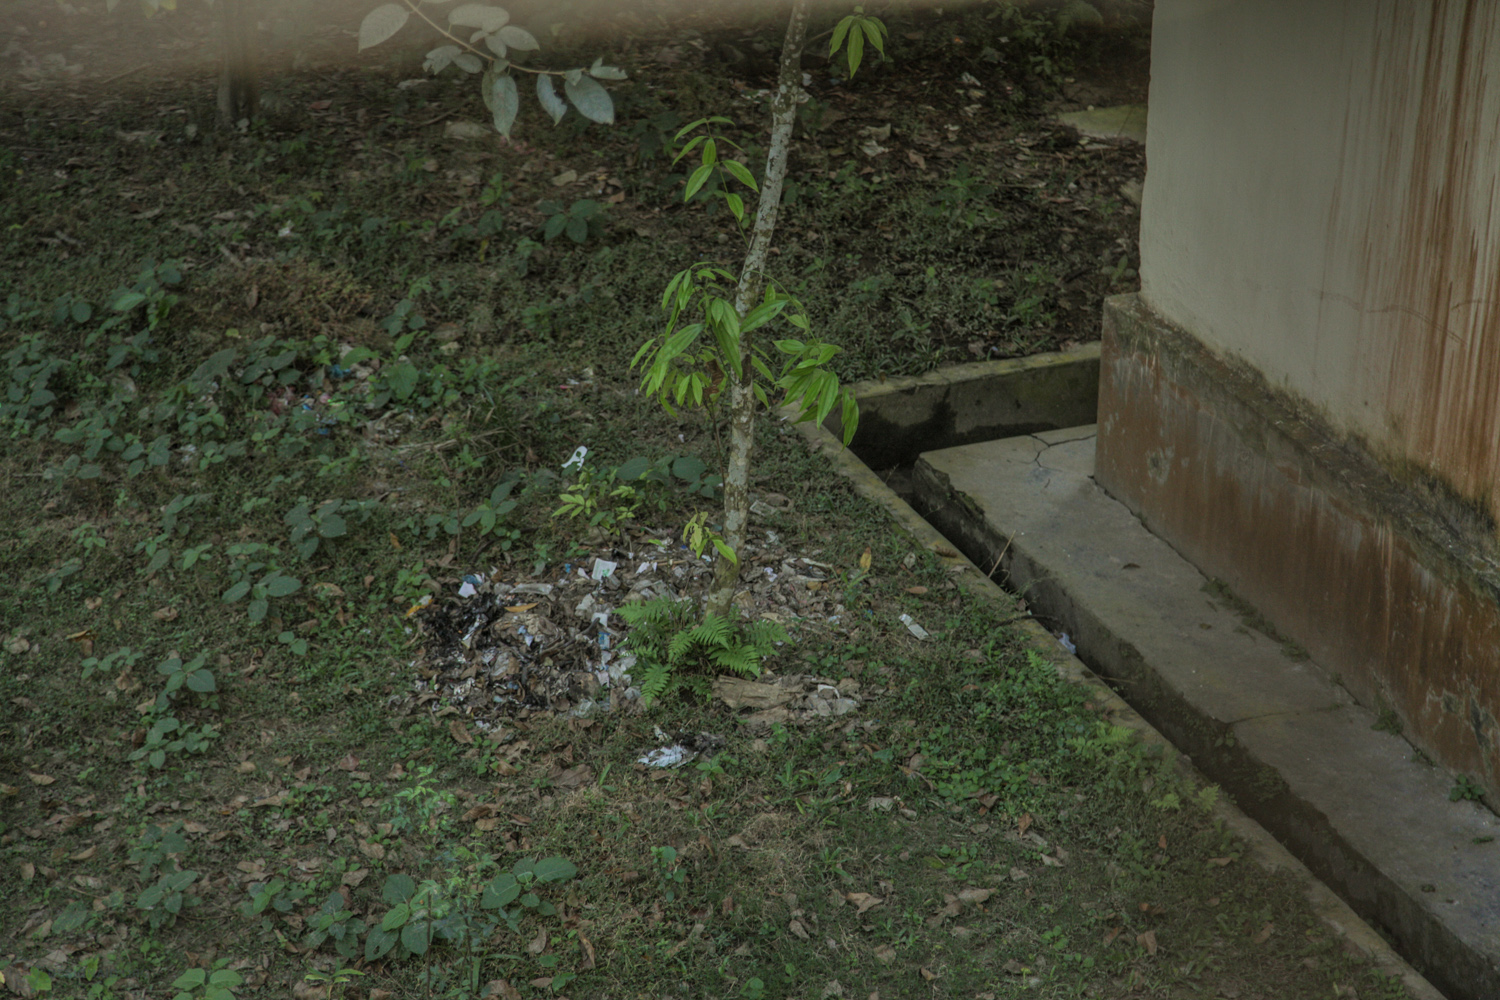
[780,396,1443,1000]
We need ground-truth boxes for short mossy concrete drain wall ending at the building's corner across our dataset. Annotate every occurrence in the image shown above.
[825,342,1100,469]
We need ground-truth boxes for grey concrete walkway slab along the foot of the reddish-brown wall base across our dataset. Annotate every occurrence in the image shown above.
[915,427,1500,1000]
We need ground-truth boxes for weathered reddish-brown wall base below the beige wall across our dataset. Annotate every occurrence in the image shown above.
[1095,295,1500,805]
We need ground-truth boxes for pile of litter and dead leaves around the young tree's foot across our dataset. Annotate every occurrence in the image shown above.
[408,532,894,730]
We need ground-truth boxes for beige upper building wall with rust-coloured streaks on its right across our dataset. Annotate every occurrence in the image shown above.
[1142,0,1500,514]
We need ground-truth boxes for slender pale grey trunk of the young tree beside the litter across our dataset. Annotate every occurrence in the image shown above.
[705,0,807,616]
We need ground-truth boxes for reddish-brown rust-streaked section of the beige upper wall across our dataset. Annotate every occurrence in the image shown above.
[1332,0,1500,516]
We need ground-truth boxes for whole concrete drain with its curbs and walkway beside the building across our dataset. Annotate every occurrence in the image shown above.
[803,343,1476,1000]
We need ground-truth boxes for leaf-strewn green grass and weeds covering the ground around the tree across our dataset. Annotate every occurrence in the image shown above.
[0,1,1401,1000]
